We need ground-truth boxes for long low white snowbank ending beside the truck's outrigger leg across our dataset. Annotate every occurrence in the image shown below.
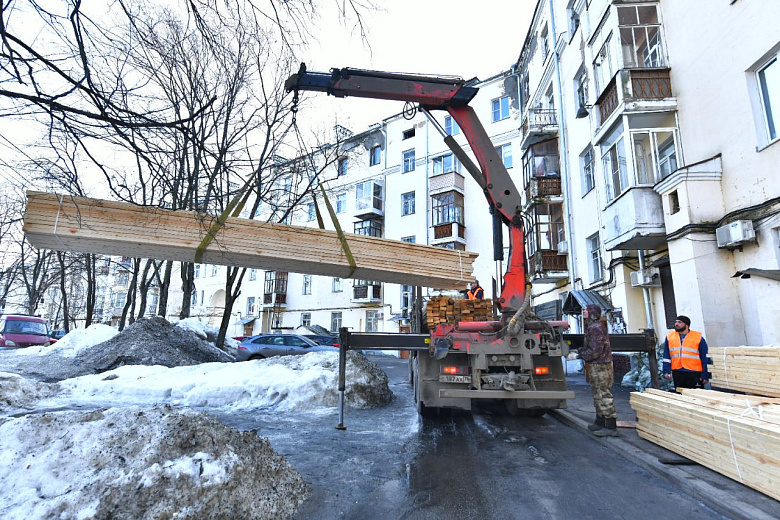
[44,352,393,413]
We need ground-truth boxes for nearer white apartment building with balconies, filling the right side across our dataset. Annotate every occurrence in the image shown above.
[516,0,780,346]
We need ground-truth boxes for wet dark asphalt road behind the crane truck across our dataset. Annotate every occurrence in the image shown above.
[212,357,723,520]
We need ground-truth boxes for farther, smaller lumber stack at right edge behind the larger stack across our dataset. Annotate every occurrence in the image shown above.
[709,346,780,397]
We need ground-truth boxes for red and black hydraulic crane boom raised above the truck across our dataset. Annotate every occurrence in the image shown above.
[285,64,526,310]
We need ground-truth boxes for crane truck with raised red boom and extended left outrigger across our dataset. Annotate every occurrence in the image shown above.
[285,64,574,418]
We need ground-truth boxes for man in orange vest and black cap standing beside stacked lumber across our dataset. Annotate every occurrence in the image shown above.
[663,316,710,388]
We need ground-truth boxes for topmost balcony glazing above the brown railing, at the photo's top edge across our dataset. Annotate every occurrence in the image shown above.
[617,5,666,68]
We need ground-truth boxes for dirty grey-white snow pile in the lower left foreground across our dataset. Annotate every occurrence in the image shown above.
[0,407,308,520]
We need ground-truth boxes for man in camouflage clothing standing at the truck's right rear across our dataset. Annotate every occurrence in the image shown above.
[579,305,617,437]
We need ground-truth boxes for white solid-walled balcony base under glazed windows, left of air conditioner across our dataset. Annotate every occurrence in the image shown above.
[604,186,666,251]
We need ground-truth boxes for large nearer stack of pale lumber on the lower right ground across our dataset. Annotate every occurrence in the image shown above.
[631,389,780,500]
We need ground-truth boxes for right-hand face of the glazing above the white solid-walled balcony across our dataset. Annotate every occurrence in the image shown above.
[631,130,677,184]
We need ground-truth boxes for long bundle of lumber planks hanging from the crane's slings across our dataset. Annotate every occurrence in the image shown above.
[24,192,477,289]
